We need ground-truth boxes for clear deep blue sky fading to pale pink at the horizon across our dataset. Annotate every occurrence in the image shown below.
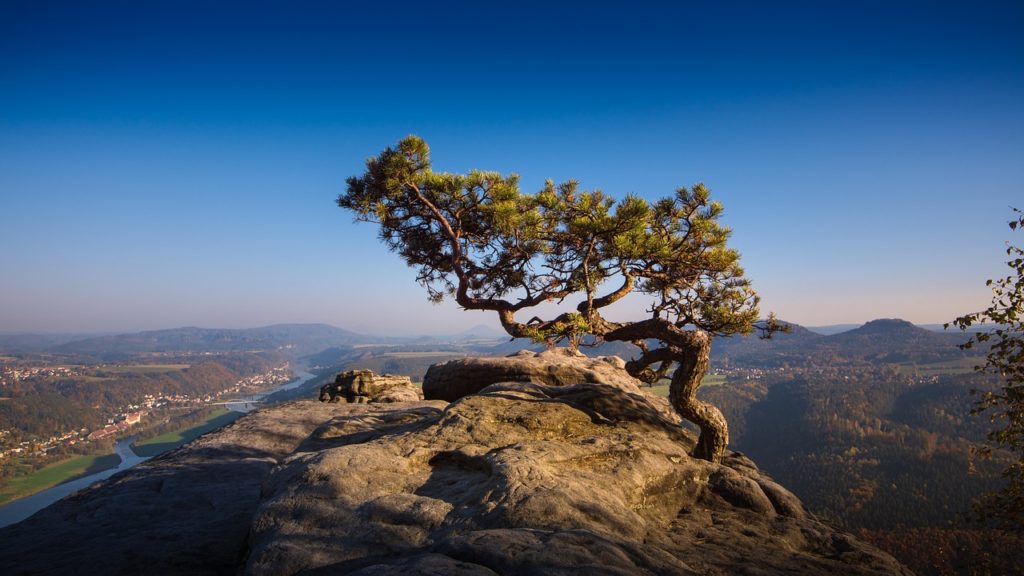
[0,0,1024,334]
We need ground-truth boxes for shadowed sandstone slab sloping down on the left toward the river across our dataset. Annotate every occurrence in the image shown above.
[0,402,439,575]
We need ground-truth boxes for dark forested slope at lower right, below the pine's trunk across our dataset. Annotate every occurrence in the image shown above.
[701,364,1024,575]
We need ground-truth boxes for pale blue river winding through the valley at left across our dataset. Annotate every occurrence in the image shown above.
[0,372,315,528]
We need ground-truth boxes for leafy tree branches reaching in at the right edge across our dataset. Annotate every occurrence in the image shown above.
[946,208,1024,530]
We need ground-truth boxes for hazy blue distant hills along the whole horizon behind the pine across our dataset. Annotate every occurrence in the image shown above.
[0,319,967,367]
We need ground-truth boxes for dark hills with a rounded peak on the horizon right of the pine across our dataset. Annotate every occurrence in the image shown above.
[712,319,981,368]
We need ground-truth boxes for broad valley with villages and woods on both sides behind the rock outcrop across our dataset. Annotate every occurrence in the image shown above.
[0,320,1024,574]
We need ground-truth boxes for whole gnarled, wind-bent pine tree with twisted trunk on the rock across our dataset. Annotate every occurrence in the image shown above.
[338,136,778,460]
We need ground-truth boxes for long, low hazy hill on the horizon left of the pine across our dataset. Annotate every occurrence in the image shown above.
[49,324,369,359]
